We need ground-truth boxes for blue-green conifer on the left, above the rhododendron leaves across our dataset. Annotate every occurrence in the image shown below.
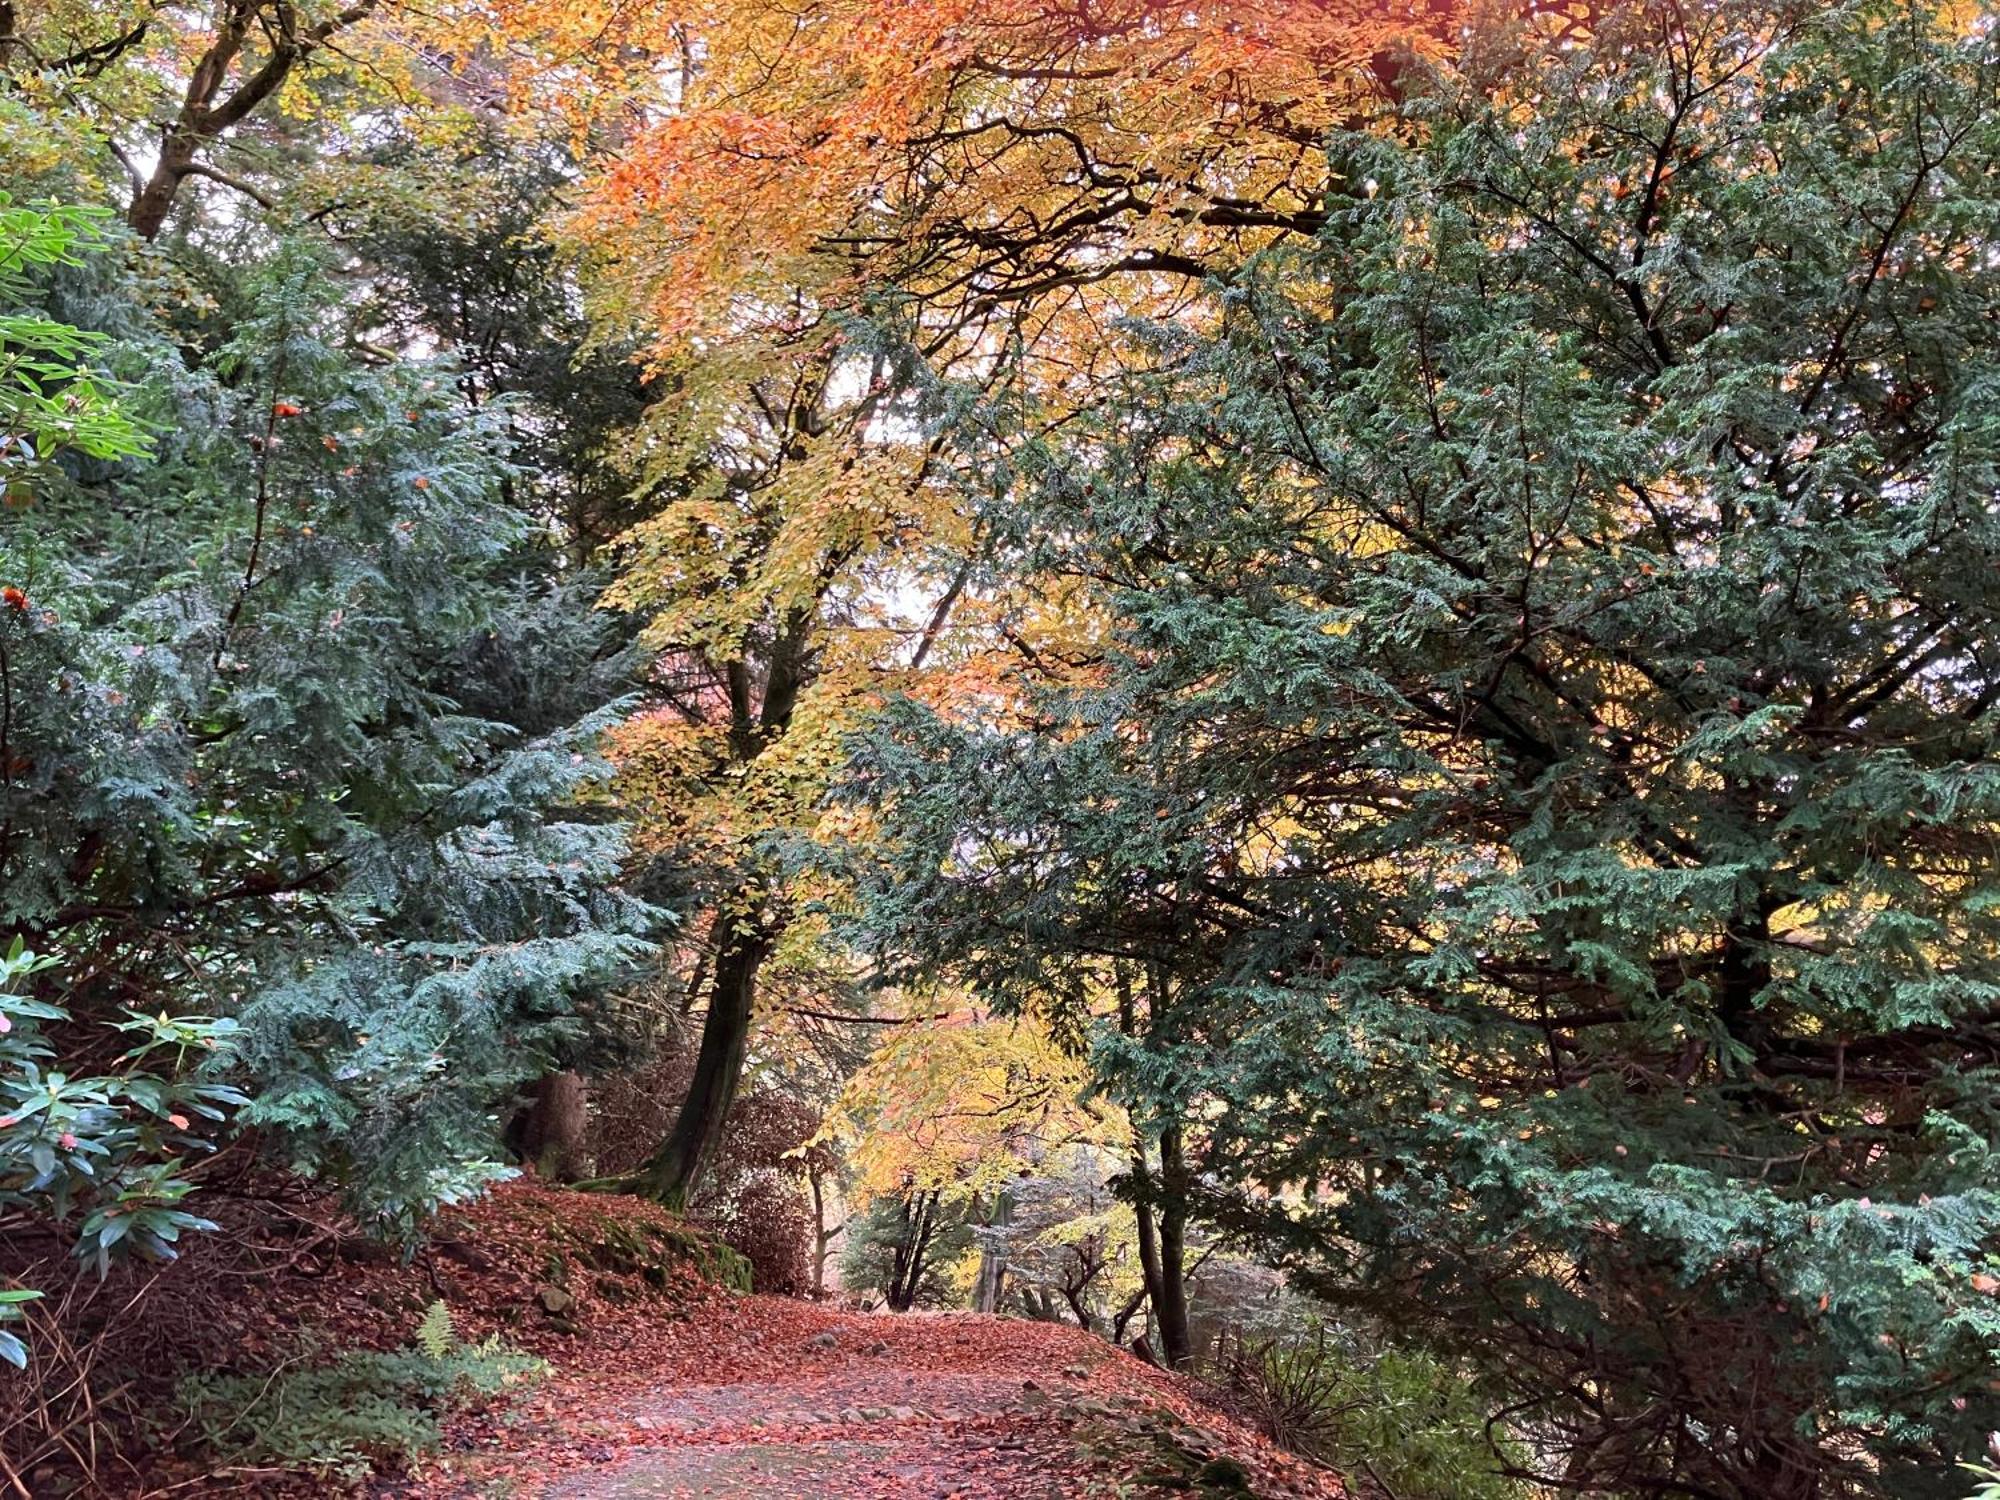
[0,220,658,1228]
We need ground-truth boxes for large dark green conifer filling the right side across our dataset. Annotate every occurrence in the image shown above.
[866,4,2000,1498]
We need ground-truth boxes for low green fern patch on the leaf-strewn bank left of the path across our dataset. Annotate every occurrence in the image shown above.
[176,1302,548,1482]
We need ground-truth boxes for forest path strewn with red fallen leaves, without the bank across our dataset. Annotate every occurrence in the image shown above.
[434,1296,1342,1500]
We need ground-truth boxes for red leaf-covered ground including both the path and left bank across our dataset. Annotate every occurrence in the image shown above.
[94,1182,1344,1500]
